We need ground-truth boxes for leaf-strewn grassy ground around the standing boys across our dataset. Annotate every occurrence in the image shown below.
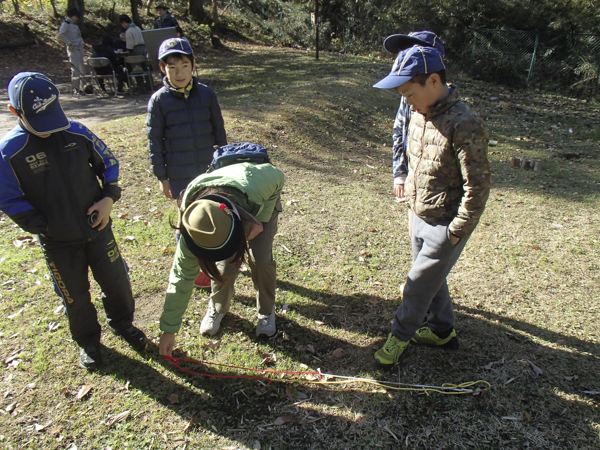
[0,43,600,449]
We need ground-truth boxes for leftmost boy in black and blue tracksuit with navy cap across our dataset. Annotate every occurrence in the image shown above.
[0,72,147,370]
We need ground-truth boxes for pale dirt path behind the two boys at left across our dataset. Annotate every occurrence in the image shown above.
[0,85,150,137]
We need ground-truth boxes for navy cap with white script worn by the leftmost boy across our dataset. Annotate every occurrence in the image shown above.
[8,72,69,134]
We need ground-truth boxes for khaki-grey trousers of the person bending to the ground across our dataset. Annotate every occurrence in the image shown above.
[211,200,281,315]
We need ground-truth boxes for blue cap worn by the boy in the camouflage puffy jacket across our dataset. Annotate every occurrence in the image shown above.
[373,45,446,89]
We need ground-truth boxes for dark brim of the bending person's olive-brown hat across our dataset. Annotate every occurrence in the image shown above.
[180,194,245,262]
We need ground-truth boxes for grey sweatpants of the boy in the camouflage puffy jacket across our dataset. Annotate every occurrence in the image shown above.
[392,214,469,341]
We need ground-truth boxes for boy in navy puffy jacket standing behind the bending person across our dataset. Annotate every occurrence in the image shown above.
[146,38,227,287]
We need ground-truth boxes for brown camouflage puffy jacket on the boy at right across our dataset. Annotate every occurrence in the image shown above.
[404,90,490,237]
